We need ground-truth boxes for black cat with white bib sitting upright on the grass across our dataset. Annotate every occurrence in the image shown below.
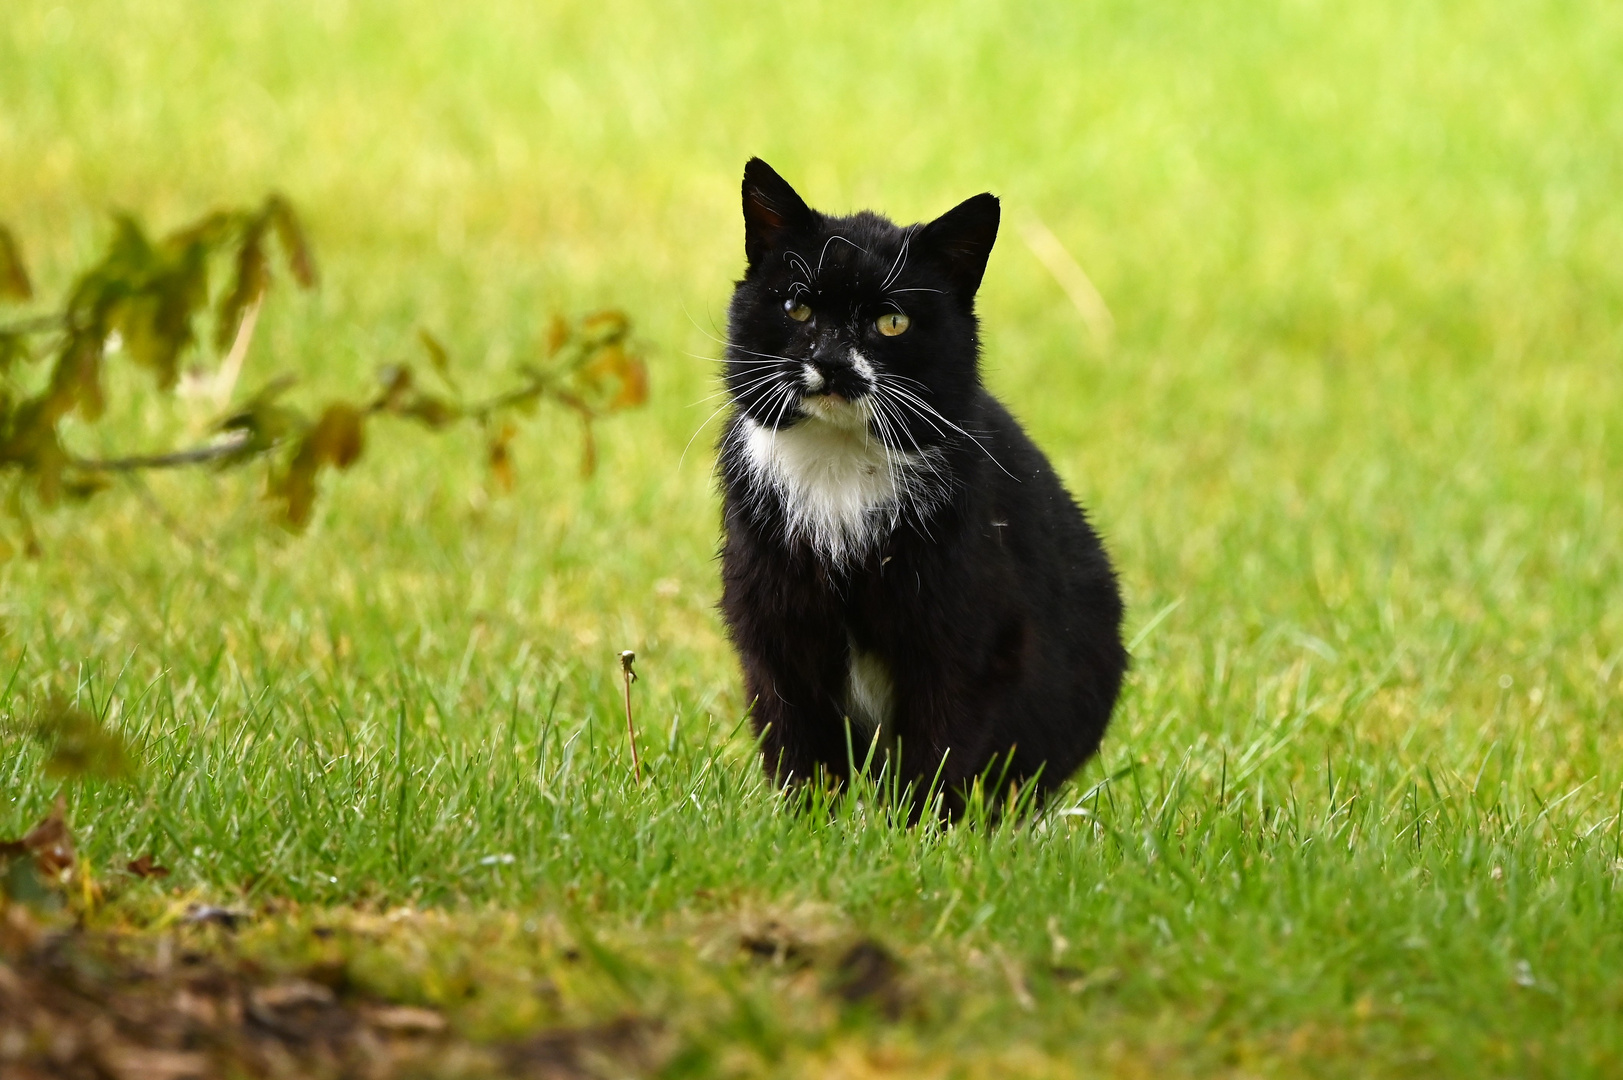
[719,158,1128,814]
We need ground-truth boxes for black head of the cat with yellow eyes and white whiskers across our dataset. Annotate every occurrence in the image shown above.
[727,158,998,451]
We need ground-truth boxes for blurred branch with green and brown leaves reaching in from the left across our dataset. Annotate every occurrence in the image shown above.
[0,195,648,554]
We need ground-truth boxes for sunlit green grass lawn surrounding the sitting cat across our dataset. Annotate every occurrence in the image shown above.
[0,0,1623,1077]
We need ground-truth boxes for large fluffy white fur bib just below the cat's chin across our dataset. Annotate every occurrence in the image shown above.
[740,398,940,564]
